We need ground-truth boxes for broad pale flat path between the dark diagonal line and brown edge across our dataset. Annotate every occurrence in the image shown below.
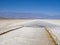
[0,27,54,45]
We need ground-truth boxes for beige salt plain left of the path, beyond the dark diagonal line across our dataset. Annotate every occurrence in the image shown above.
[0,19,30,34]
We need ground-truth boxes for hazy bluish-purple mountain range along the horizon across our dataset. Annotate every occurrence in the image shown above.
[0,12,60,19]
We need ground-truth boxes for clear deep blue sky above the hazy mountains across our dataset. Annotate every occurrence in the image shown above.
[0,0,60,18]
